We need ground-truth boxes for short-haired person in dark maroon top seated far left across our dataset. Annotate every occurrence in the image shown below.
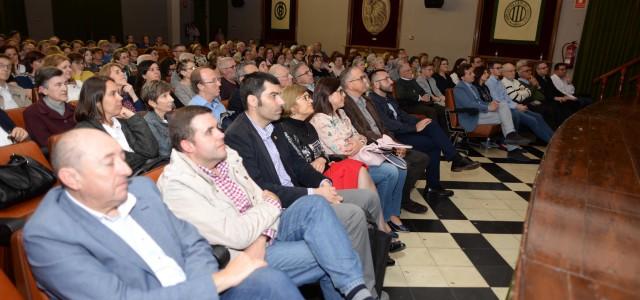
[24,67,76,150]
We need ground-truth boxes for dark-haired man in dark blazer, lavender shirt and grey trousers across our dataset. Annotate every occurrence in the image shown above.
[225,72,380,297]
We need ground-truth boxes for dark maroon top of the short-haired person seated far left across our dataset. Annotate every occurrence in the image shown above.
[23,101,76,150]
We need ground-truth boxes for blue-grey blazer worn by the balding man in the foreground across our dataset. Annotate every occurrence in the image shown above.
[24,177,218,300]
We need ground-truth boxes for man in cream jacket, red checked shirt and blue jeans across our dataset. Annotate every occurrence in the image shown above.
[158,106,371,299]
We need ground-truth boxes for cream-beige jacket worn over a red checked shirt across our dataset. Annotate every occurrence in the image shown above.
[158,147,280,256]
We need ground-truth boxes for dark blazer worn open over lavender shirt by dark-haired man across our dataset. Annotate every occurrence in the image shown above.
[224,113,327,207]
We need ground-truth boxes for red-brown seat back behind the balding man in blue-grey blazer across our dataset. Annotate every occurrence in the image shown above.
[11,229,49,300]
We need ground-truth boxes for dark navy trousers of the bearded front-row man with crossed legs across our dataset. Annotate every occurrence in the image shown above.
[396,122,457,189]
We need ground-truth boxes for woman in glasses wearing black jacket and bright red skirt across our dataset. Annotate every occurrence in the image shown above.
[280,85,403,251]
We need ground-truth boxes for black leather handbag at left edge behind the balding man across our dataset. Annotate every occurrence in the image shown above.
[0,154,56,209]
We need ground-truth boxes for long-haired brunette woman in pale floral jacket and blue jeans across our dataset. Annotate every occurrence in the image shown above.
[309,76,408,239]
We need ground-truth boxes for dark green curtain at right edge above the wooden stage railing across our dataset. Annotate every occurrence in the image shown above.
[573,0,640,98]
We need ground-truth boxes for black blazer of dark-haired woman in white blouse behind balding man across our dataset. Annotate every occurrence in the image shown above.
[76,114,158,173]
